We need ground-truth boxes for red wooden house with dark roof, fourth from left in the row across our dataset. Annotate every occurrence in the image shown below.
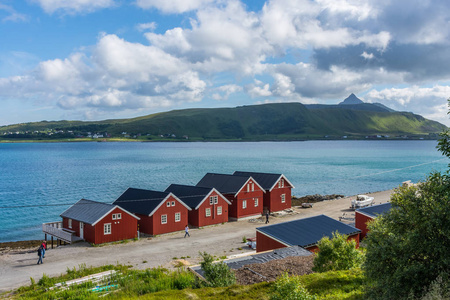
[196,173,265,220]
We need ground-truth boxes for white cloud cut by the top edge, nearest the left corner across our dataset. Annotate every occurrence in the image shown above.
[33,0,115,14]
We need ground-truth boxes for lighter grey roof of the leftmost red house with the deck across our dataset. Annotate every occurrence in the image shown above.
[60,199,115,225]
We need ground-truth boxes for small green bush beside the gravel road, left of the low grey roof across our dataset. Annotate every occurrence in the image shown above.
[200,252,236,287]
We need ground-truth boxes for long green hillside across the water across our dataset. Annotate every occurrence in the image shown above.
[0,103,446,140]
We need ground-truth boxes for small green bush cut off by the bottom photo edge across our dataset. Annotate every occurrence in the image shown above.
[270,273,316,300]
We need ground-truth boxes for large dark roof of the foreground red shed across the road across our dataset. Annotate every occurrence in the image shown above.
[256,215,361,247]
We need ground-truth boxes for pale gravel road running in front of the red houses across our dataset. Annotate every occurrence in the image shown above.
[0,190,393,292]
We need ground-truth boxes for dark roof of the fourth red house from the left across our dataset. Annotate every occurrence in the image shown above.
[196,173,250,194]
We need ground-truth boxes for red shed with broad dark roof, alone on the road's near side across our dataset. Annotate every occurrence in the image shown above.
[256,215,361,252]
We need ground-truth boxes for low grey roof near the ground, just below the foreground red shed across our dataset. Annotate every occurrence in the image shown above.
[191,246,313,277]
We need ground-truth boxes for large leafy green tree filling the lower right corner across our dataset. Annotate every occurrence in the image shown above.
[364,172,450,299]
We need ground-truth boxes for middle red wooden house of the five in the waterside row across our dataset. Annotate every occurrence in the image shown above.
[165,184,231,227]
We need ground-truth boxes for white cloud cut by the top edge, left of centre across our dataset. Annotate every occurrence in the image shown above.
[136,0,214,13]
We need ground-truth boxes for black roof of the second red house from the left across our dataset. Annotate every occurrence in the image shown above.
[113,188,170,216]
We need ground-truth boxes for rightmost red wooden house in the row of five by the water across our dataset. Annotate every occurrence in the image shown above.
[233,171,294,212]
